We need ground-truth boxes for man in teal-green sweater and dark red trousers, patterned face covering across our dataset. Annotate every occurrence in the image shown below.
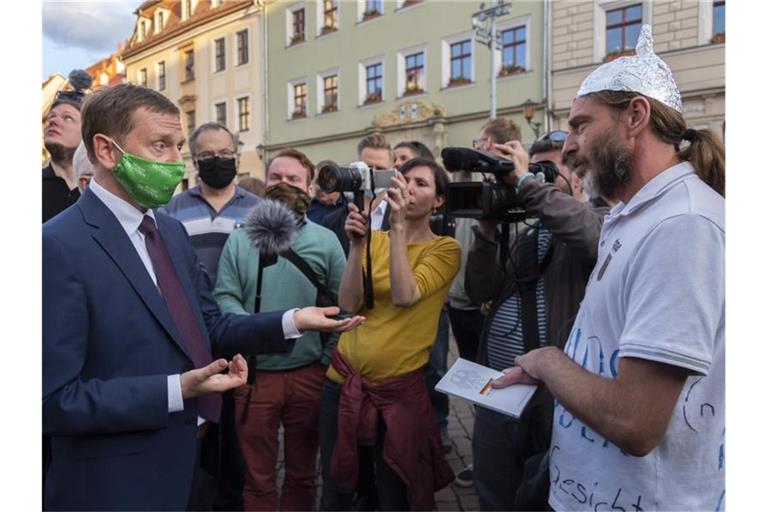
[214,150,346,510]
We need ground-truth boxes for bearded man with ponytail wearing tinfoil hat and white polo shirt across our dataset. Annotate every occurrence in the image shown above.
[493,26,725,510]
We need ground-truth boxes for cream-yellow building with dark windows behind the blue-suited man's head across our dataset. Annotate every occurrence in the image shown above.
[123,0,264,187]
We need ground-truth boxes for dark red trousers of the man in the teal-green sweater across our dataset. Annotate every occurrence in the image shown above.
[235,363,327,510]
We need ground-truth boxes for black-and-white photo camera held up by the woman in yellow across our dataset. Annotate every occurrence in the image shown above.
[317,162,397,210]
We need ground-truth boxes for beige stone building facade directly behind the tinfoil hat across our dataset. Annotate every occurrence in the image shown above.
[549,0,725,138]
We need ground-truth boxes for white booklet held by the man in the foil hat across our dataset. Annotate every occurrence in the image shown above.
[435,358,536,418]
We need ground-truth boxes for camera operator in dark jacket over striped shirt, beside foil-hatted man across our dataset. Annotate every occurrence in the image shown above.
[465,131,607,510]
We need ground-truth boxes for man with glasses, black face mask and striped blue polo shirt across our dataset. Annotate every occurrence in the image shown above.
[160,123,261,510]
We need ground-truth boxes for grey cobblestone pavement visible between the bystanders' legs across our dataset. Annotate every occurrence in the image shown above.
[277,333,479,511]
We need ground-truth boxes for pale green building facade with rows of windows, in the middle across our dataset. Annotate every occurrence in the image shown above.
[264,0,545,162]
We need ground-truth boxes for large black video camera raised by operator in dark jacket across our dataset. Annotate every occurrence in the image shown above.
[441,147,559,223]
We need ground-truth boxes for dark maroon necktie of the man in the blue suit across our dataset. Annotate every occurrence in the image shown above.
[139,215,221,422]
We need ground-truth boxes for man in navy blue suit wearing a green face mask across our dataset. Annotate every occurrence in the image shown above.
[43,84,362,510]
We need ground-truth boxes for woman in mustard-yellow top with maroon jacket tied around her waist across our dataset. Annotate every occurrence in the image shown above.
[320,158,461,510]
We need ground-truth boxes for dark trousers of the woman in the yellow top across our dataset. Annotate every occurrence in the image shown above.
[320,379,408,510]
